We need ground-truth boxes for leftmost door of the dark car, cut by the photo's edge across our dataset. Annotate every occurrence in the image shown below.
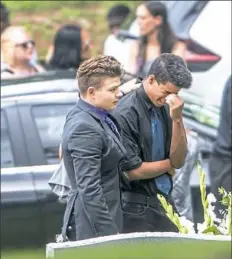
[1,105,41,248]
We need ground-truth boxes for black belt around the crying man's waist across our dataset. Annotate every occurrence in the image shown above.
[122,192,163,206]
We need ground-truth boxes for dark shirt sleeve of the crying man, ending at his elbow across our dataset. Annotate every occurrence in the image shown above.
[118,110,142,171]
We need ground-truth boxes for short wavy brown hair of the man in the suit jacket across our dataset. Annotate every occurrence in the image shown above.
[77,55,124,94]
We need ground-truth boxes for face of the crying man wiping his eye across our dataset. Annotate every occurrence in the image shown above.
[146,76,180,107]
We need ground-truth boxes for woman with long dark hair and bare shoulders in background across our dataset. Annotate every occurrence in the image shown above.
[126,1,186,77]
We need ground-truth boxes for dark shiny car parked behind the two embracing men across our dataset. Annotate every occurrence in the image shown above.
[1,70,218,247]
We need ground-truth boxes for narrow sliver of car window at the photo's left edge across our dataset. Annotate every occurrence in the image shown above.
[1,111,15,168]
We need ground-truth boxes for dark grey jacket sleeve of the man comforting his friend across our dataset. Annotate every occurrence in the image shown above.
[68,125,118,235]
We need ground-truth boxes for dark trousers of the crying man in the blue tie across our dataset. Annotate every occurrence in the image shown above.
[122,192,179,233]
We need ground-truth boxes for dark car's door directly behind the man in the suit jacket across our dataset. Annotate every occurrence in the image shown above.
[21,101,75,246]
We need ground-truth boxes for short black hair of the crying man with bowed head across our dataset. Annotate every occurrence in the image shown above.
[148,53,192,89]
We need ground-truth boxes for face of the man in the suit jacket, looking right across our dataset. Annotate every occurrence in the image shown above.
[88,77,122,111]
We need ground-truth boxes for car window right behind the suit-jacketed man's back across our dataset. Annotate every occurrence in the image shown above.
[32,103,74,164]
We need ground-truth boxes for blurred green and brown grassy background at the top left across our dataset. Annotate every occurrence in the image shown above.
[2,1,141,59]
